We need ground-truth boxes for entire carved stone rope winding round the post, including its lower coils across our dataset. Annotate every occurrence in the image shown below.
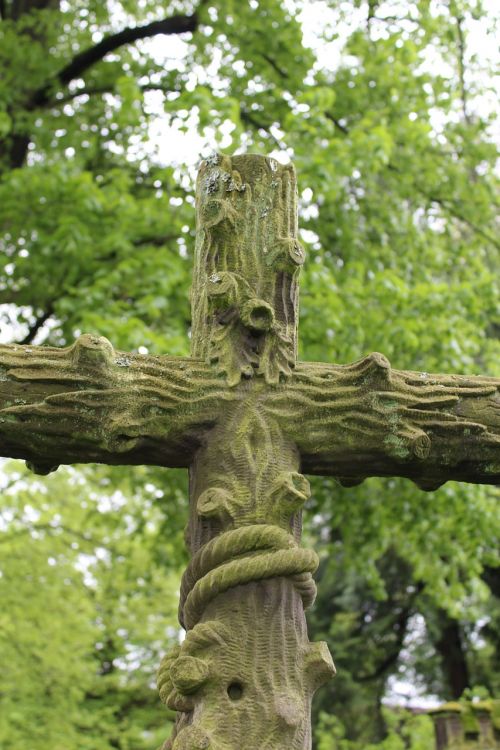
[158,524,318,750]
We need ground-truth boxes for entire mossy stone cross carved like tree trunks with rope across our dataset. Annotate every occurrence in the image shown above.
[0,156,500,750]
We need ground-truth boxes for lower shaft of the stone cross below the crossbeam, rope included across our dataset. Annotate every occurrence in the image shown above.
[159,412,334,750]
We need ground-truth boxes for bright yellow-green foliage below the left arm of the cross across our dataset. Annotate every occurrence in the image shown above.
[0,467,184,750]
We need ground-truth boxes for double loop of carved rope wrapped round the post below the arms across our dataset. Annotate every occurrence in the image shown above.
[179,524,318,630]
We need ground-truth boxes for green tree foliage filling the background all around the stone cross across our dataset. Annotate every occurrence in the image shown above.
[0,0,500,750]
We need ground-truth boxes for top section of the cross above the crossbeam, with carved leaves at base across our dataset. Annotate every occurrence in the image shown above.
[192,155,304,385]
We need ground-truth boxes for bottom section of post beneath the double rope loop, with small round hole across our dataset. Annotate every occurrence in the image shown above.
[158,577,333,750]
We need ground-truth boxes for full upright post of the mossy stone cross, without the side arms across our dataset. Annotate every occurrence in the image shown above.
[159,156,334,750]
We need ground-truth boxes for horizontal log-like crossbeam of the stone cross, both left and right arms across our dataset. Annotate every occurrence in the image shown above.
[0,335,500,490]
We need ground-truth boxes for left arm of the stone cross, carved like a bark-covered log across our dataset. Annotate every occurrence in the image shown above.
[0,334,223,473]
